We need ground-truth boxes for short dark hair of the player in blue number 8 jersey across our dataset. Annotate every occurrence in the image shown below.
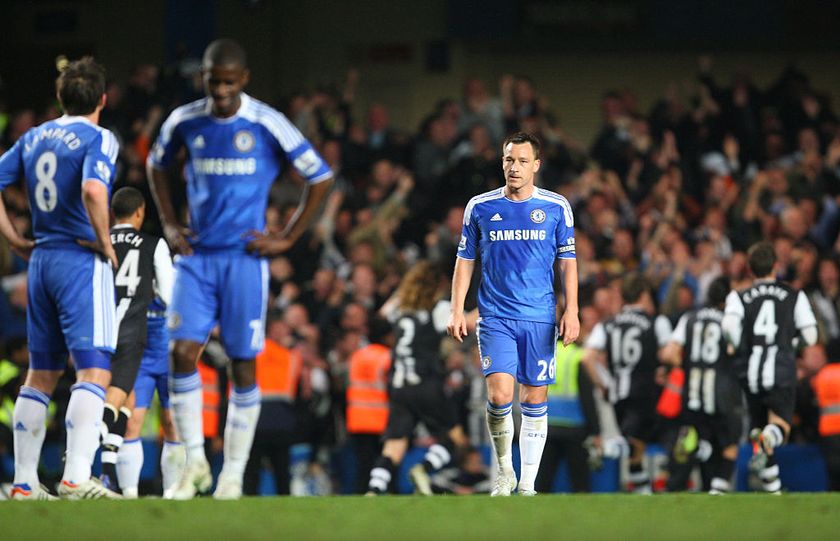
[55,56,105,115]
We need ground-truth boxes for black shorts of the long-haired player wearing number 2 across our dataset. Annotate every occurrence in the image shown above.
[385,381,458,440]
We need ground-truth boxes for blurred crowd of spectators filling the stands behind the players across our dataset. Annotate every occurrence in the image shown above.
[0,57,840,493]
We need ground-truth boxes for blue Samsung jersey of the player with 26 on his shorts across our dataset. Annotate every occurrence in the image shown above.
[458,187,575,323]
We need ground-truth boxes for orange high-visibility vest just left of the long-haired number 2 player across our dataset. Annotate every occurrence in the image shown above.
[347,344,391,434]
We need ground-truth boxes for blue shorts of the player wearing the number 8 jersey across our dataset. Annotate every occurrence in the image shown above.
[26,246,117,370]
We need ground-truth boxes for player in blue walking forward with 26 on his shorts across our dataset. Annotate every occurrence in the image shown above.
[447,133,580,496]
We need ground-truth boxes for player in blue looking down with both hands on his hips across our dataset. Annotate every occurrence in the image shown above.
[148,39,332,499]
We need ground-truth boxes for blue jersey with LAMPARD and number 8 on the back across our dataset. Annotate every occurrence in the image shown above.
[0,116,119,249]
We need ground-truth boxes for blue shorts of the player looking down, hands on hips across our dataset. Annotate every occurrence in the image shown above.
[167,252,268,359]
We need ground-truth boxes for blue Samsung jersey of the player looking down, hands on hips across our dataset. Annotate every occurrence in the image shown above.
[149,93,332,252]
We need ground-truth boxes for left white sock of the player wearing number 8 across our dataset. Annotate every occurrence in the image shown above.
[12,386,50,488]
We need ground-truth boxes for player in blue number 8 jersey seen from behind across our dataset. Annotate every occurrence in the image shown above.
[0,57,119,499]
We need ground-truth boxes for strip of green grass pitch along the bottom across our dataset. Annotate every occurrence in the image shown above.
[0,494,840,541]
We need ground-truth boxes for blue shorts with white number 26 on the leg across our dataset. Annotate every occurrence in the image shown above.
[476,317,557,387]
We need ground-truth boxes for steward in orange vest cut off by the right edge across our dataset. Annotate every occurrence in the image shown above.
[811,361,840,491]
